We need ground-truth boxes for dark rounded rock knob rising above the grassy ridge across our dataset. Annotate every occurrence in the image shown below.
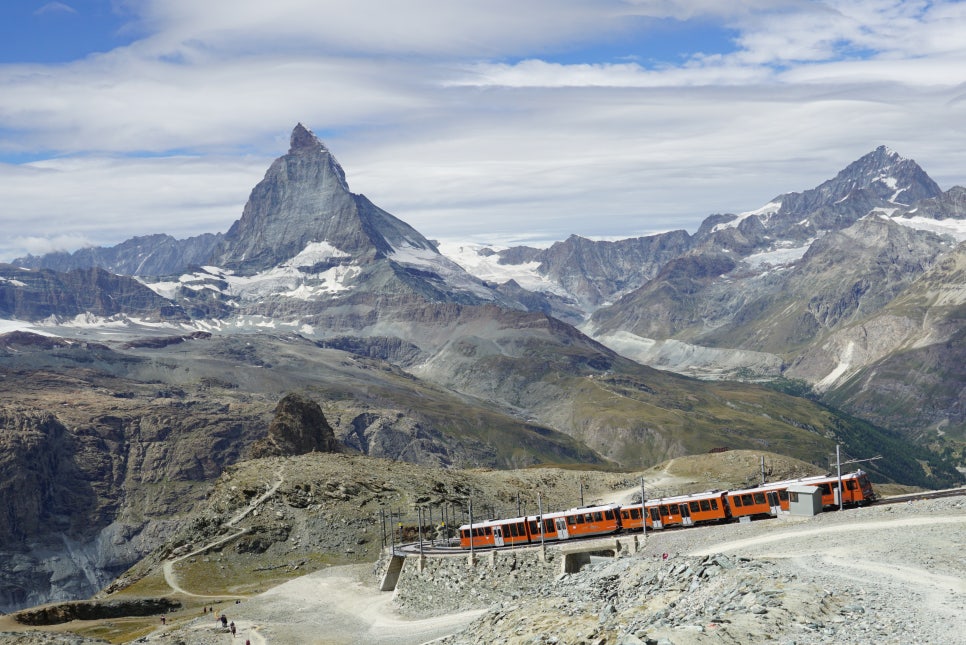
[251,394,340,459]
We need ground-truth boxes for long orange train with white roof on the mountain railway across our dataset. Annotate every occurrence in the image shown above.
[459,470,876,549]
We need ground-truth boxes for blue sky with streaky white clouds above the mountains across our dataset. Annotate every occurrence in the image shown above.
[0,0,966,261]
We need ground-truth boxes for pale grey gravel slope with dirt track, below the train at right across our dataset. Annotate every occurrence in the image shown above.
[440,497,966,645]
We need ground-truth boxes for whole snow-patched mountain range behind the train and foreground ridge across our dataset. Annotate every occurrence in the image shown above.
[0,124,966,610]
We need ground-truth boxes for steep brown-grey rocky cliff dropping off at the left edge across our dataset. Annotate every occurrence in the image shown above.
[0,336,267,611]
